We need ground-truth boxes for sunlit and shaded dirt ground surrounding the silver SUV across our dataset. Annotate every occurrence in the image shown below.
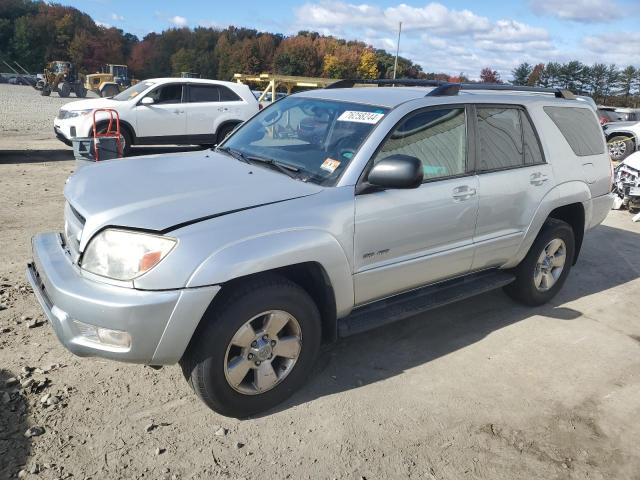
[0,151,640,480]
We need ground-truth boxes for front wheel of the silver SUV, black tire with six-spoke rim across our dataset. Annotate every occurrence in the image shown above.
[180,275,322,418]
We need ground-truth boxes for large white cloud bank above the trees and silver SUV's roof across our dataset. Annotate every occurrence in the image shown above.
[293,0,558,79]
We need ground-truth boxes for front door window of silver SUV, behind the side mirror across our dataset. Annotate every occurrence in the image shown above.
[374,107,467,180]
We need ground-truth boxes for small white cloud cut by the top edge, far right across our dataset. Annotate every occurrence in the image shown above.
[530,0,622,23]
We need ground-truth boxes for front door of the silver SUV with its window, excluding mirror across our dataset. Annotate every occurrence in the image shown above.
[354,106,478,305]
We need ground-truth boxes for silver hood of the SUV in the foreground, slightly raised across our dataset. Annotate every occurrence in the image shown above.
[64,150,322,250]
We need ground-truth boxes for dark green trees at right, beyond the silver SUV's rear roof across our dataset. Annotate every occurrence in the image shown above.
[511,60,640,106]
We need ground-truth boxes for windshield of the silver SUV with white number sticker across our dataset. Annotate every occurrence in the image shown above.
[223,97,388,186]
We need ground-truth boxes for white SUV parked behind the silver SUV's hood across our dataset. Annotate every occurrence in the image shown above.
[53,78,258,154]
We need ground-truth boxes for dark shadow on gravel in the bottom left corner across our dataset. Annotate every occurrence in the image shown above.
[0,368,31,478]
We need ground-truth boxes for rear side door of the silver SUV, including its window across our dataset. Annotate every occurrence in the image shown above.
[472,105,554,270]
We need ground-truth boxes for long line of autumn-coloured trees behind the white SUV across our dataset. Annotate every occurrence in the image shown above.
[0,0,424,80]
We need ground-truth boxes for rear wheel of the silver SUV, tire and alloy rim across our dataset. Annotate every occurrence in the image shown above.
[504,218,575,306]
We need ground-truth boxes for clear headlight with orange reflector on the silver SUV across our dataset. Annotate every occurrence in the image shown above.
[82,228,176,280]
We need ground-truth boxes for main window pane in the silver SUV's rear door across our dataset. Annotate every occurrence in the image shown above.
[476,107,524,171]
